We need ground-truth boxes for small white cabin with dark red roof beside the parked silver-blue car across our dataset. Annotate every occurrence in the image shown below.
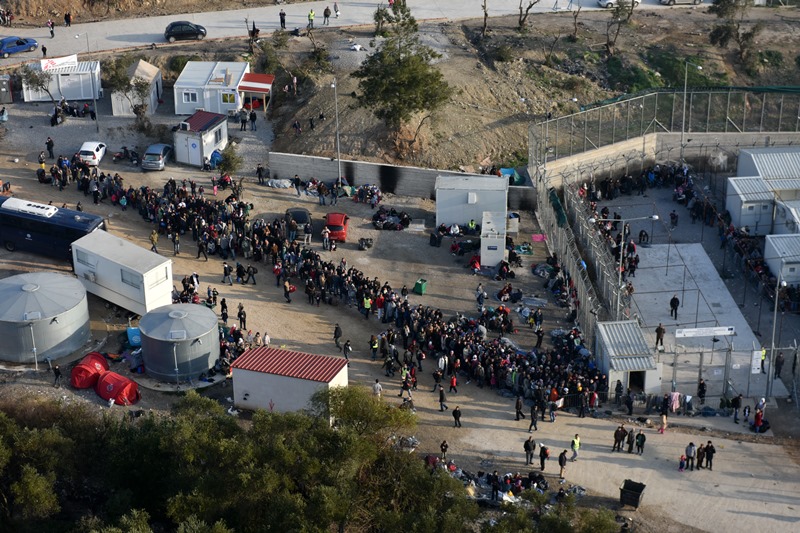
[172,111,228,168]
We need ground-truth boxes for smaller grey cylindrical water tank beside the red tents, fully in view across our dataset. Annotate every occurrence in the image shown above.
[139,304,219,382]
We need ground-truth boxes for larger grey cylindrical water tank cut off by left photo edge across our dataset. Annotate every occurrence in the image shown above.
[0,272,91,363]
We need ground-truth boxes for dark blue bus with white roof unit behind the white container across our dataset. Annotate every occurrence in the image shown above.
[0,197,106,262]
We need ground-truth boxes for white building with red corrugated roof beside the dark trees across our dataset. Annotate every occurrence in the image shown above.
[231,346,348,413]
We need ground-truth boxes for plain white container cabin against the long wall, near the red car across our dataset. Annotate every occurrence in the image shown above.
[436,175,508,226]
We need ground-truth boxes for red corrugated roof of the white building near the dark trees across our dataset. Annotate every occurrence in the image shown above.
[231,346,347,383]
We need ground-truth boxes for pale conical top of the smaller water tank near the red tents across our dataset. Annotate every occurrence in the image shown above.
[139,304,218,342]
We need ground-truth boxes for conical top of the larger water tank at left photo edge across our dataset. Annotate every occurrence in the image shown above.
[0,272,86,322]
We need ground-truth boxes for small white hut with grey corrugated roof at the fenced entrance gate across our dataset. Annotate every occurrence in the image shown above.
[595,320,662,394]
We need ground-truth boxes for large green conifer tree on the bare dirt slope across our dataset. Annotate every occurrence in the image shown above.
[353,2,453,134]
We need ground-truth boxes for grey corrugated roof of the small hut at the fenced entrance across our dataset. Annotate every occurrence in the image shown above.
[597,320,656,372]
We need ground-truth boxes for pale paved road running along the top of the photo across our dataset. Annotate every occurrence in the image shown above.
[0,0,684,66]
